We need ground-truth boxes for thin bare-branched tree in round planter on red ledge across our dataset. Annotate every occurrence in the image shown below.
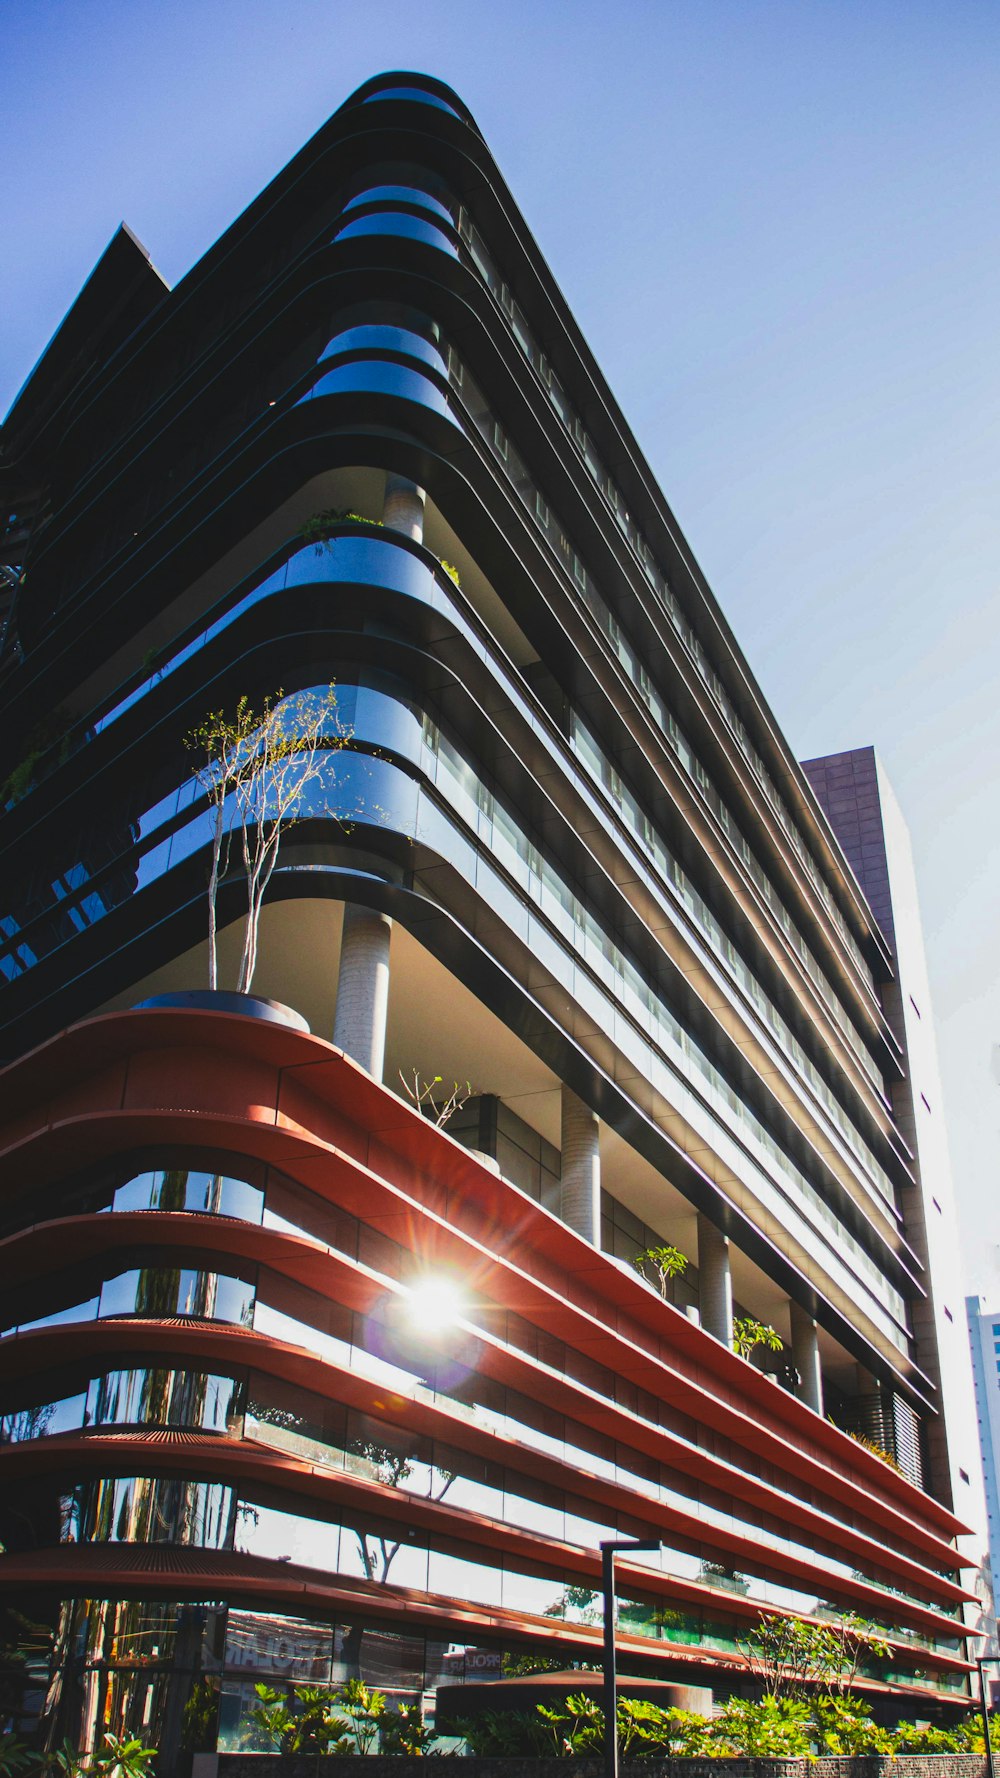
[185,685,352,994]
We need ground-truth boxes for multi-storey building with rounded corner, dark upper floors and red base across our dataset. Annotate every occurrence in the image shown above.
[0,75,975,1778]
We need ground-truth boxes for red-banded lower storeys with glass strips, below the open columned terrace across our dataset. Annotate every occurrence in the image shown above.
[0,1008,968,1728]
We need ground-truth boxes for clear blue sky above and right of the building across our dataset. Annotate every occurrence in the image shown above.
[0,0,1000,1301]
